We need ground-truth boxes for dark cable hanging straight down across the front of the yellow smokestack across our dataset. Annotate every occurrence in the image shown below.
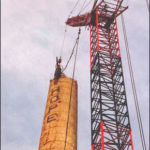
[64,28,81,150]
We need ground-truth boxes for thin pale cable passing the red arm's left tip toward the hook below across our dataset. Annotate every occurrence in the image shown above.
[60,0,80,56]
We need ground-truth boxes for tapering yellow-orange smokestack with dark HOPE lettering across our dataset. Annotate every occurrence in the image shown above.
[39,73,77,150]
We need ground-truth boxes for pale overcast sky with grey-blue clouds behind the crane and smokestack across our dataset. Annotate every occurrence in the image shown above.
[1,0,149,150]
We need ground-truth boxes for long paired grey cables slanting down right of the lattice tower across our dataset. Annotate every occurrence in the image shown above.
[121,14,146,150]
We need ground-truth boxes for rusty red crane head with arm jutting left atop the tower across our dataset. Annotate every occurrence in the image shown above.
[66,0,128,29]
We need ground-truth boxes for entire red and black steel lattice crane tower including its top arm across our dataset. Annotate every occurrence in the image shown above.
[67,0,133,150]
